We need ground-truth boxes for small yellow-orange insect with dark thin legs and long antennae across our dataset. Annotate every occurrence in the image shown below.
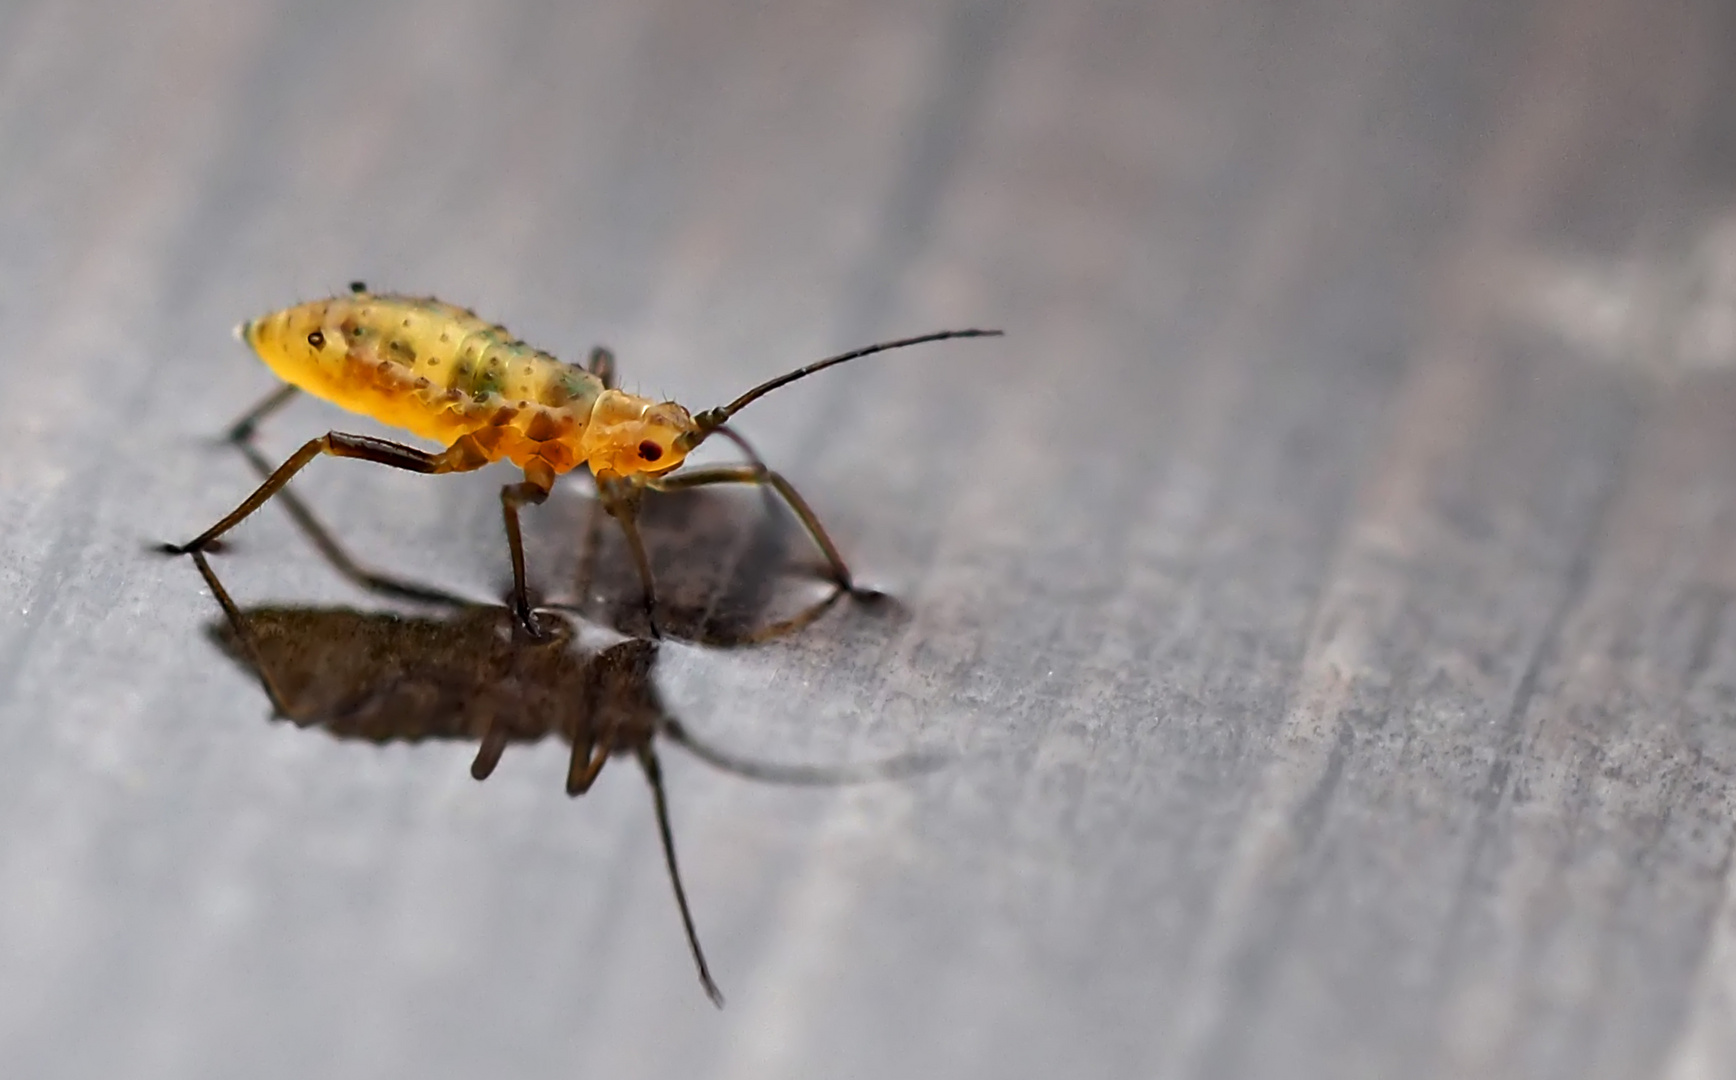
[163,281,1000,634]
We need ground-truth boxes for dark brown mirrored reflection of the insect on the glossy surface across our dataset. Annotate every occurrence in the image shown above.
[193,552,943,1007]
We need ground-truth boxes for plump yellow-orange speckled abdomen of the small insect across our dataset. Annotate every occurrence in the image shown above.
[241,293,602,472]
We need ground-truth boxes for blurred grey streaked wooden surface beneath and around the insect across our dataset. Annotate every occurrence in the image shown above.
[0,0,1736,1080]
